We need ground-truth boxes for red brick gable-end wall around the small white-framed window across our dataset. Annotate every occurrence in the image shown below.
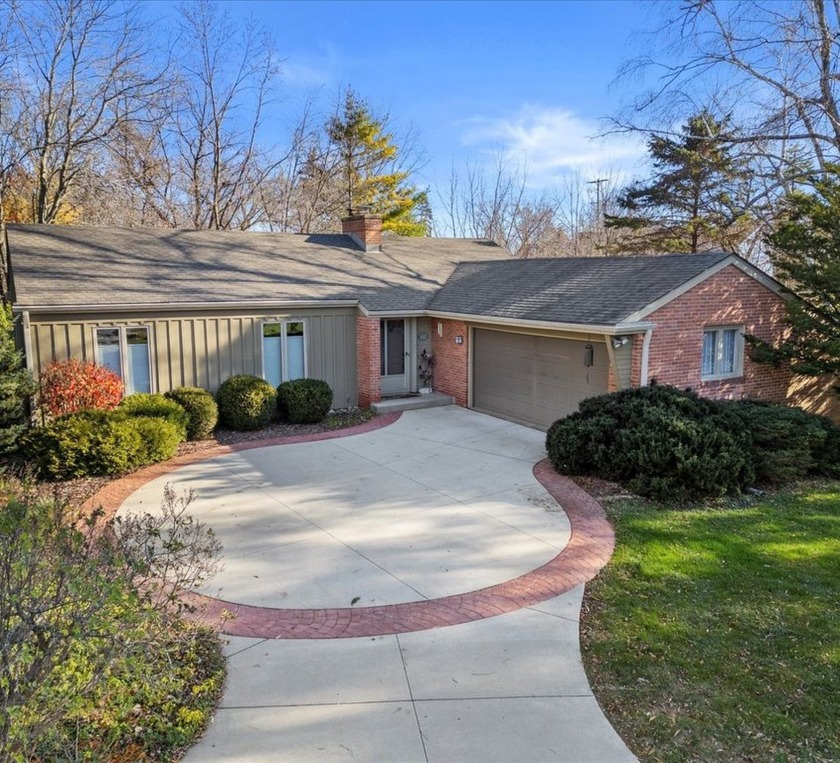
[644,264,790,402]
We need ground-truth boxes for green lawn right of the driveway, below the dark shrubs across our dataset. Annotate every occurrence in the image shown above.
[581,482,840,761]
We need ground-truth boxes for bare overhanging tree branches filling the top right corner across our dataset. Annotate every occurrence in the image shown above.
[614,0,840,190]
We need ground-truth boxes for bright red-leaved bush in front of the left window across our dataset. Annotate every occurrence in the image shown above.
[39,360,124,416]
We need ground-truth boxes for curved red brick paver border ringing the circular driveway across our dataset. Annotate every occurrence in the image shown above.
[88,414,615,639]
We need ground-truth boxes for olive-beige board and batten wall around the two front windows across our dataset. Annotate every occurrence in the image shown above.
[24,308,358,408]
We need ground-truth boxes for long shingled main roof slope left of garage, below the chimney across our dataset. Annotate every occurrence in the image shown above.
[8,225,510,311]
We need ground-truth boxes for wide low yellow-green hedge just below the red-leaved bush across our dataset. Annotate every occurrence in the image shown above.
[23,409,182,480]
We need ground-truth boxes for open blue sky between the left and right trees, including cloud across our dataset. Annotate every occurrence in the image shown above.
[151,0,653,203]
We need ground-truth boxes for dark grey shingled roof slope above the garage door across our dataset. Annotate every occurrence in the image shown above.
[429,252,732,326]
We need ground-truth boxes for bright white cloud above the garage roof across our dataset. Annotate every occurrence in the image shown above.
[461,105,645,186]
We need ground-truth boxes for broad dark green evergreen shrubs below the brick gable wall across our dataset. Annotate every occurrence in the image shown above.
[546,385,840,503]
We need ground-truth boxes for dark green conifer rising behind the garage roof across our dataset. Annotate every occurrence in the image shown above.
[605,111,748,253]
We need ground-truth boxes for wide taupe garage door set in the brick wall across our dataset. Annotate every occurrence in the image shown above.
[472,329,609,429]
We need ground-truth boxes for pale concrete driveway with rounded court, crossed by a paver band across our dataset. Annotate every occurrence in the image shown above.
[120,406,635,763]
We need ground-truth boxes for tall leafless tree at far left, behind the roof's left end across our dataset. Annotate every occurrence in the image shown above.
[5,0,161,223]
